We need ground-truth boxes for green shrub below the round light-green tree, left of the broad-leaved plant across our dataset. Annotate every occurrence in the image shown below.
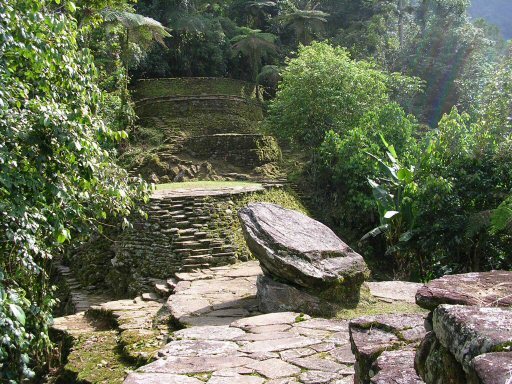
[315,104,416,237]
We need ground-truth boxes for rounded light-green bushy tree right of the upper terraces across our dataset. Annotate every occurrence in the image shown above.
[269,43,398,147]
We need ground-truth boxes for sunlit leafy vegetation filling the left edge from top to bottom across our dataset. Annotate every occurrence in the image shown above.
[0,0,147,382]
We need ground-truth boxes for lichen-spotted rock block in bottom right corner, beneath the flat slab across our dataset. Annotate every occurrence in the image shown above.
[415,304,512,384]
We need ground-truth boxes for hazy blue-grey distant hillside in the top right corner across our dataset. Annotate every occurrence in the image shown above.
[470,0,512,39]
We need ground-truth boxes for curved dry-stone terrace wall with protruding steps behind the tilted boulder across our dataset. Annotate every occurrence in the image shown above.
[71,184,304,295]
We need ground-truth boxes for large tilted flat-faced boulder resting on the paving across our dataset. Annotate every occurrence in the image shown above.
[239,203,368,302]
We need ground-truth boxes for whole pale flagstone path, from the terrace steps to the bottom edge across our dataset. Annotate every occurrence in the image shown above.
[125,261,422,384]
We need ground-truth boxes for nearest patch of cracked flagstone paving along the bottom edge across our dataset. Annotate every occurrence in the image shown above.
[126,312,353,384]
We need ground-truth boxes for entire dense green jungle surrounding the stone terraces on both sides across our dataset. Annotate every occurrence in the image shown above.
[0,0,512,383]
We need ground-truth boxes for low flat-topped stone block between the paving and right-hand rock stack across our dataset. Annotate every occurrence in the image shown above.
[349,314,426,384]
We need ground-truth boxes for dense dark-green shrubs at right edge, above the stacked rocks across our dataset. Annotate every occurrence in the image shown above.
[366,109,512,279]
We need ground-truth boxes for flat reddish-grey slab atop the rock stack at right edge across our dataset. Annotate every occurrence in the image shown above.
[416,271,512,310]
